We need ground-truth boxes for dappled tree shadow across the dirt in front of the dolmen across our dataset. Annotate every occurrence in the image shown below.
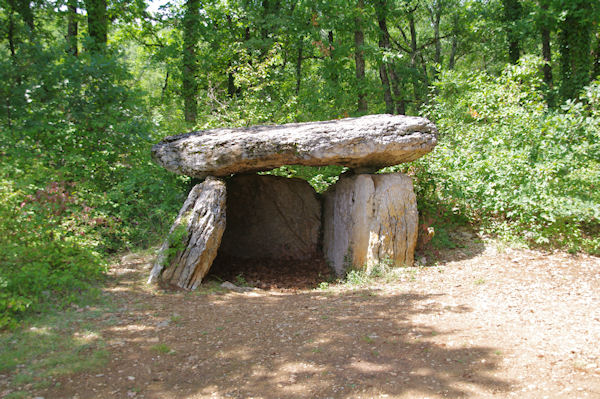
[40,255,510,398]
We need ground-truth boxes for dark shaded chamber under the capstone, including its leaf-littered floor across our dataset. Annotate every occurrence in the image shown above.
[206,175,333,289]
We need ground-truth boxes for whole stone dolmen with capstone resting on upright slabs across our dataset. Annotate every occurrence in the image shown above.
[148,115,437,290]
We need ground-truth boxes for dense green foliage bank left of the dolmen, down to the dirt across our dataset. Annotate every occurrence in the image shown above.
[0,42,186,328]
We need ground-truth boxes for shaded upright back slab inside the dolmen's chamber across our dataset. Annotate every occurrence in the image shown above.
[219,175,321,260]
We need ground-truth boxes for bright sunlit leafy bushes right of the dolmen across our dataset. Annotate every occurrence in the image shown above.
[410,57,600,253]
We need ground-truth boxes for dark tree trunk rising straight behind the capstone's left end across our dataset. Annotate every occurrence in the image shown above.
[182,0,200,123]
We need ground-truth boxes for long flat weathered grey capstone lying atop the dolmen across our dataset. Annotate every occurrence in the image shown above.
[152,115,437,178]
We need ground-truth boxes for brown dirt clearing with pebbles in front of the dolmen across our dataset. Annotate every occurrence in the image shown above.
[27,239,600,399]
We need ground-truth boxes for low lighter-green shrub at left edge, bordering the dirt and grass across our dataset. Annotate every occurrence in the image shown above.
[0,179,104,328]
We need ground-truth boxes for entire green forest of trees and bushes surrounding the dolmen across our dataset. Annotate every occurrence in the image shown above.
[0,0,600,328]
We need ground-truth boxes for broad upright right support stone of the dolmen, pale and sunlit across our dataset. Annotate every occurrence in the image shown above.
[323,173,418,275]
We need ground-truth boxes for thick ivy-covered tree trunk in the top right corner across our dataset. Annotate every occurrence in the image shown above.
[559,0,592,99]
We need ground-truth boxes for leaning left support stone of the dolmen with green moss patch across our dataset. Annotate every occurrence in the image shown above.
[148,177,226,289]
